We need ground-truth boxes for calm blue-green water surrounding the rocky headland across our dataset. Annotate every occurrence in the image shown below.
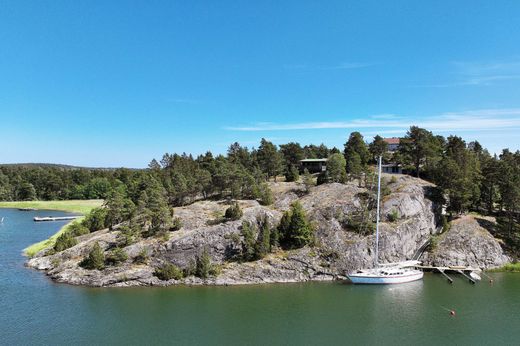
[0,209,520,345]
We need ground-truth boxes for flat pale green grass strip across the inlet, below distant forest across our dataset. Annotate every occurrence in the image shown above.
[0,199,103,214]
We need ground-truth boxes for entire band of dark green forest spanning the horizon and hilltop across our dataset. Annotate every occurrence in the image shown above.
[0,126,520,234]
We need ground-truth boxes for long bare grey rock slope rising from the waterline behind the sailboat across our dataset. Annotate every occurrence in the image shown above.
[28,175,504,286]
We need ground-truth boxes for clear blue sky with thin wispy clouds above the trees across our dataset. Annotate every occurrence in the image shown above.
[0,0,520,167]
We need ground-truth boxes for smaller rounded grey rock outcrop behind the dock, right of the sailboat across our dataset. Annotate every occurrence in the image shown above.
[425,215,511,269]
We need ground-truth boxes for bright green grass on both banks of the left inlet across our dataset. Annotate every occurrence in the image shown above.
[0,199,103,257]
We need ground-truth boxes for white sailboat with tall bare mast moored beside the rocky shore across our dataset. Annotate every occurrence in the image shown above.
[347,157,423,284]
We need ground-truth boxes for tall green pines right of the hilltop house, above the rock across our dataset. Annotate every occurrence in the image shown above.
[344,126,520,232]
